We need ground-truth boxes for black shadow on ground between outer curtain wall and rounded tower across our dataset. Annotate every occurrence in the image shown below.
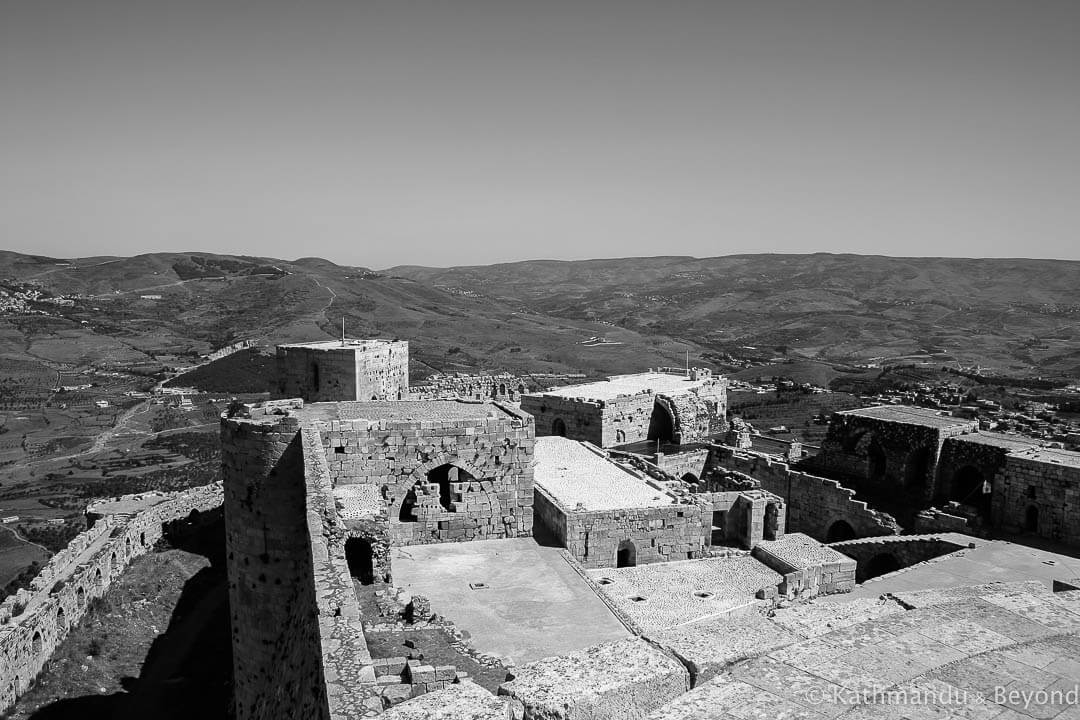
[16,522,233,720]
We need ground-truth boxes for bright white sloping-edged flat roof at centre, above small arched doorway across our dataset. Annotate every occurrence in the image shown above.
[532,436,675,512]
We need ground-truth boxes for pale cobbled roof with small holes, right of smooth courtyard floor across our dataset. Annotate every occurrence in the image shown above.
[586,555,783,633]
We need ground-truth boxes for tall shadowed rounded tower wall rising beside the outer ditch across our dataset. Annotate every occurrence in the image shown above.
[214,410,329,720]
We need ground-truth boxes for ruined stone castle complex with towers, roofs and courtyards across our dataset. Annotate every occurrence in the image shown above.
[6,340,1080,720]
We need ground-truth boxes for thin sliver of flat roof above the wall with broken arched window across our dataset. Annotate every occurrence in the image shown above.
[296,400,517,422]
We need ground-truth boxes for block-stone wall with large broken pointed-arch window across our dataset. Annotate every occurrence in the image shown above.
[319,406,534,545]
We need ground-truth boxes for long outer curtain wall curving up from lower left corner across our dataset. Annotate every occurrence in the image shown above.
[0,484,221,712]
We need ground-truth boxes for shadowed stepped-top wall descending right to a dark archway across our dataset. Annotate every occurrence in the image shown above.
[714,448,900,542]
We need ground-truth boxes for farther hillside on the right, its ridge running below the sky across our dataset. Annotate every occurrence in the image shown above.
[387,255,1080,377]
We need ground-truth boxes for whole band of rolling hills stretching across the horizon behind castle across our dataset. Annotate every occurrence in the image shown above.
[0,253,1080,378]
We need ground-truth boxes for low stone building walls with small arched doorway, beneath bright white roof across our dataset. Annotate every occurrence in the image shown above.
[536,486,708,568]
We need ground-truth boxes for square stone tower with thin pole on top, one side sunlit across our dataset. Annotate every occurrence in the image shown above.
[273,339,408,403]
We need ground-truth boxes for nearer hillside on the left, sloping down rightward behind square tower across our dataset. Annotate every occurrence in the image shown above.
[0,253,704,378]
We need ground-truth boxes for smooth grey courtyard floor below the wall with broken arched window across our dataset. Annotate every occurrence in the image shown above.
[392,538,630,664]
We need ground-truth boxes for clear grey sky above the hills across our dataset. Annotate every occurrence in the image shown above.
[0,0,1080,268]
